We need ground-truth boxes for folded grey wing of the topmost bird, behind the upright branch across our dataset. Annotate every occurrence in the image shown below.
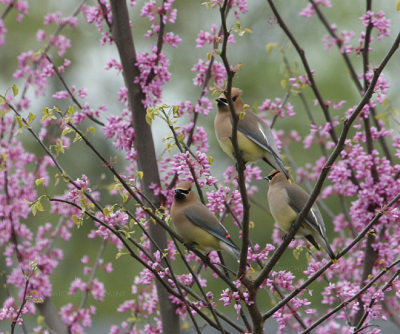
[231,110,278,156]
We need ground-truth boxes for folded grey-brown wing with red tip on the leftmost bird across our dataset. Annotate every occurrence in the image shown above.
[184,205,238,249]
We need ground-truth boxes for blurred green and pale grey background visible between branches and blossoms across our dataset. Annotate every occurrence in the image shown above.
[0,0,400,332]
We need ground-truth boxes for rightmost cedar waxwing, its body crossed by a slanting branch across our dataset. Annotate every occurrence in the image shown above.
[266,170,336,260]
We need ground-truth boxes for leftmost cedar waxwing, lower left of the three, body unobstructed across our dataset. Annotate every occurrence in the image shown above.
[171,181,240,257]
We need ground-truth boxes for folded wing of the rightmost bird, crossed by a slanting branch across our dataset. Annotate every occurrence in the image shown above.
[286,184,326,236]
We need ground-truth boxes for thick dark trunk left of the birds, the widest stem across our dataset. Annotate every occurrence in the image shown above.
[111,0,179,333]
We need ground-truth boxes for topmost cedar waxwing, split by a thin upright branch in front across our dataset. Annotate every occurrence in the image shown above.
[214,88,289,179]
